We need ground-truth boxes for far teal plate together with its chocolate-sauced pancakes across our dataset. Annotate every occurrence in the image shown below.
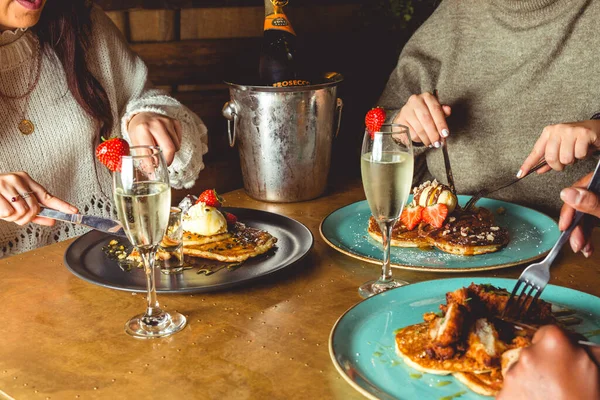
[320,195,560,272]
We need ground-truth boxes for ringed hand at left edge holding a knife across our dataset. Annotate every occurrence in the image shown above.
[0,172,77,226]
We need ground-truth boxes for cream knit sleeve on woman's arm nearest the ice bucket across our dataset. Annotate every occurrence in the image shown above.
[88,6,208,189]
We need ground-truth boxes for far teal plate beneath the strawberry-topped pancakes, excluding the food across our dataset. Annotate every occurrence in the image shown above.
[320,195,560,272]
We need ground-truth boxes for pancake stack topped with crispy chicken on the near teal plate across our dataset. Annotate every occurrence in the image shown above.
[395,283,556,396]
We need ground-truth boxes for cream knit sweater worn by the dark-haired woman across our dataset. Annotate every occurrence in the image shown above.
[0,8,208,257]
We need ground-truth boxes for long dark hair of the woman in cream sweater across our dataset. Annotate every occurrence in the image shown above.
[33,0,113,138]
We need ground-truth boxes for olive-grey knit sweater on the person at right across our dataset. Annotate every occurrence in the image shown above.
[379,0,600,214]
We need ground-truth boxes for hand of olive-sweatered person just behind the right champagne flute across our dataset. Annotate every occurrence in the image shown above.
[393,93,452,148]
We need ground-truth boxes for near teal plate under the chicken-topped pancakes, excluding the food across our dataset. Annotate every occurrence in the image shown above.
[329,278,600,400]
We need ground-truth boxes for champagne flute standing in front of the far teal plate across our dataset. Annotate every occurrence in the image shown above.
[358,124,414,298]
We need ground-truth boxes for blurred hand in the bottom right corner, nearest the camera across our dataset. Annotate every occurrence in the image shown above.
[496,325,600,400]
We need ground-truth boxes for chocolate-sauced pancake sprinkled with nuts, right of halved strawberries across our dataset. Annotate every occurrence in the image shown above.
[419,208,509,256]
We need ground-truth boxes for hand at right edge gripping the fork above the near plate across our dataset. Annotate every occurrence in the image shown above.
[558,172,600,258]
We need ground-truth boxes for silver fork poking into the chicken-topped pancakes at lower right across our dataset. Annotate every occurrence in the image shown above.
[502,161,600,320]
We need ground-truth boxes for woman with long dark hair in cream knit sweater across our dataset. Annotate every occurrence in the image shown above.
[0,0,207,257]
